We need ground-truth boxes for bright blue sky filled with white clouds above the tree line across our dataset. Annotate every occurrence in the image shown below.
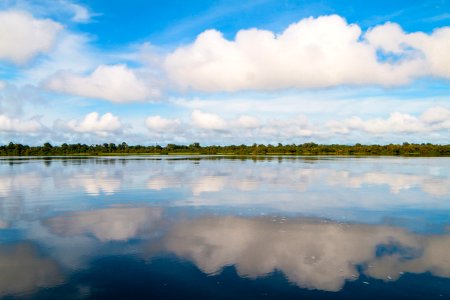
[0,0,450,145]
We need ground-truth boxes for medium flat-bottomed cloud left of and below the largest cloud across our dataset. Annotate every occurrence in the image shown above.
[45,64,159,102]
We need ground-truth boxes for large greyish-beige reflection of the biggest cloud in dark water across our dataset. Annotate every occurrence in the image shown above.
[164,217,450,291]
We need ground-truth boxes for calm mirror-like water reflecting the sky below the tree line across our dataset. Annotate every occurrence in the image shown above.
[0,157,450,299]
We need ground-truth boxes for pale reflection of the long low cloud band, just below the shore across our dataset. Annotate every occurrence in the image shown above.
[147,159,450,197]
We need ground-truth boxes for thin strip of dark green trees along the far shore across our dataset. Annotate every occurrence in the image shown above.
[0,142,450,156]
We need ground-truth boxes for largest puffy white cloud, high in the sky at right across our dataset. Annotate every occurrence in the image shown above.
[163,15,450,92]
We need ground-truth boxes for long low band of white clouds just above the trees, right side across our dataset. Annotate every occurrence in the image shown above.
[142,104,450,143]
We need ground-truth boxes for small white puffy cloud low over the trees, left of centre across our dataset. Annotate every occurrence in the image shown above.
[68,112,122,136]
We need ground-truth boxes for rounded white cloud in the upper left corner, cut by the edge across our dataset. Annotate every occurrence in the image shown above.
[0,11,62,64]
